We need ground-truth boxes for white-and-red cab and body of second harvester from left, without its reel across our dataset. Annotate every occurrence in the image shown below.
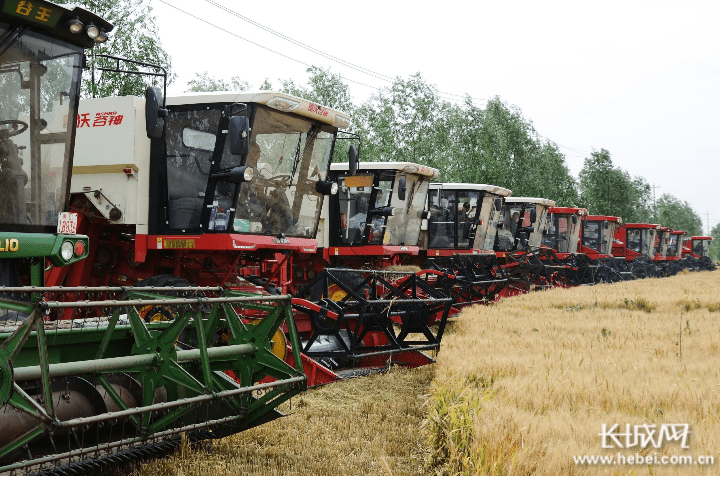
[55,88,350,293]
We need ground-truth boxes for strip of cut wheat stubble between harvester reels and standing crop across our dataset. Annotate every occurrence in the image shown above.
[124,366,435,475]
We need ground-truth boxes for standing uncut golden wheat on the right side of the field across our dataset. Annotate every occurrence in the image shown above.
[425,271,720,475]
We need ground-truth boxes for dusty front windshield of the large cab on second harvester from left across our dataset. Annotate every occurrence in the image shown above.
[234,106,336,238]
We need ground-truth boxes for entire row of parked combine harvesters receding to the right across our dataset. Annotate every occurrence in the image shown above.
[0,0,712,474]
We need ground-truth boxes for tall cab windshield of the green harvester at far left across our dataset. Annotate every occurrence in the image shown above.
[0,22,82,233]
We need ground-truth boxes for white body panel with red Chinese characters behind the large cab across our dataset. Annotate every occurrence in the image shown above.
[70,96,150,234]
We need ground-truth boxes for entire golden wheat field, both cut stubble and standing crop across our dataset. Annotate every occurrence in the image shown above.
[122,271,720,475]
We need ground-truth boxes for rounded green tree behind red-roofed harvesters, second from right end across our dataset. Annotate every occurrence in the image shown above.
[580,149,652,223]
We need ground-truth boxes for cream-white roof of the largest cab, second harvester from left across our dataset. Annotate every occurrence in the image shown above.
[167,91,350,129]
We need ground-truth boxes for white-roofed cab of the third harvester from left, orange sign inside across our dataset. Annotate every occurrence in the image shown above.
[318,162,439,258]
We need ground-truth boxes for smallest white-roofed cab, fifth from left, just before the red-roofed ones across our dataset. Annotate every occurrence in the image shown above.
[495,197,555,253]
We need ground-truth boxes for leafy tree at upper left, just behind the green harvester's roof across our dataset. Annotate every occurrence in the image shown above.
[56,0,175,97]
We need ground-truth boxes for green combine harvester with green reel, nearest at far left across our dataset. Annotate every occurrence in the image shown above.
[0,0,306,473]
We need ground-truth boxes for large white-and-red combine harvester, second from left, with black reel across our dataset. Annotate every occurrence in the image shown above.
[48,89,450,385]
